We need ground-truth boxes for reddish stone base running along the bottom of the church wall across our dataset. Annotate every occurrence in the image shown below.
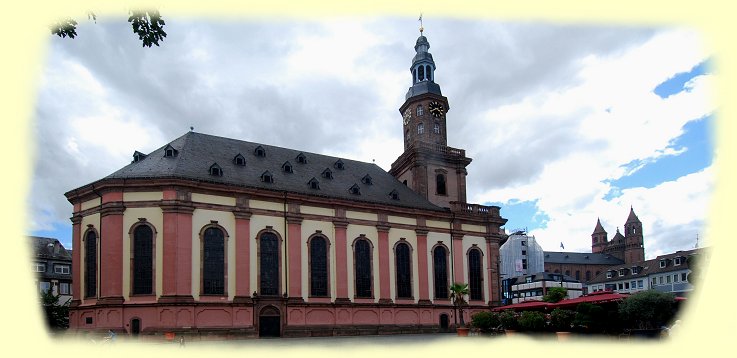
[69,298,489,340]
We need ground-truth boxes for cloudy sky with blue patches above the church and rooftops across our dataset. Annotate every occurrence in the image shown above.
[27,13,718,259]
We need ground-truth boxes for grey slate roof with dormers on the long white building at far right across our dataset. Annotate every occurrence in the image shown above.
[588,249,699,284]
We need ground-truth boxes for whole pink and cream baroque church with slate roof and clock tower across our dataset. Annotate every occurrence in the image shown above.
[65,29,506,337]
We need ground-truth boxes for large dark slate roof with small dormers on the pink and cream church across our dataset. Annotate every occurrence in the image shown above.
[105,132,447,211]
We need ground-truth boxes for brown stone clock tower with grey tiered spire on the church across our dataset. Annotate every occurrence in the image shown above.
[389,28,471,207]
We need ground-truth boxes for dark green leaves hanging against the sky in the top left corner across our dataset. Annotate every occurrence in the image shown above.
[50,10,166,47]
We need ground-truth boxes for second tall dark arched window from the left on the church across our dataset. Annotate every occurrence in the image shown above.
[131,225,154,295]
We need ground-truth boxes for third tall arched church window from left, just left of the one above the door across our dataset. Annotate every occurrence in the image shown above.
[202,227,225,295]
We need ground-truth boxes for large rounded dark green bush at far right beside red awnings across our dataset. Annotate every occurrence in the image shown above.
[619,290,676,329]
